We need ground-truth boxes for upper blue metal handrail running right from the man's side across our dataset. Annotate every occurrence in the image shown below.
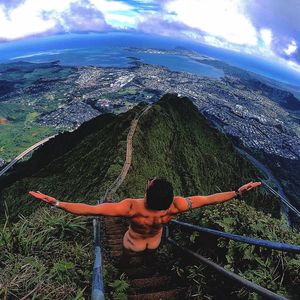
[171,220,300,254]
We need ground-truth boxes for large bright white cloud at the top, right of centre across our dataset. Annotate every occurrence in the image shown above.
[165,0,257,46]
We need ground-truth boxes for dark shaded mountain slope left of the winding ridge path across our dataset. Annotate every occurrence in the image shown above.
[0,107,140,216]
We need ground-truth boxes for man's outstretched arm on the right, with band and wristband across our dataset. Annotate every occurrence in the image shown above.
[174,181,261,213]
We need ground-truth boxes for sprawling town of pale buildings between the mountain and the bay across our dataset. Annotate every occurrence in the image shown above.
[0,57,300,160]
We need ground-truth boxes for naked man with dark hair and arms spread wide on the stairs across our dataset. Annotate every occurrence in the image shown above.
[29,178,261,252]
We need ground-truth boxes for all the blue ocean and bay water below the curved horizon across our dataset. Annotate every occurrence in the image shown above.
[0,32,300,86]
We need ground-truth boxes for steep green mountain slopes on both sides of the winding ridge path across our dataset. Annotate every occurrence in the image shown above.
[0,95,278,220]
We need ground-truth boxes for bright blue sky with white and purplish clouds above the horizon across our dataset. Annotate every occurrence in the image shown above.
[0,0,300,73]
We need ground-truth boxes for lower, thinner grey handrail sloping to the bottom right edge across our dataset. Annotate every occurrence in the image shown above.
[167,238,287,300]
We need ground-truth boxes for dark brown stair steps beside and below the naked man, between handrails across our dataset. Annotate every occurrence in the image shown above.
[102,218,187,300]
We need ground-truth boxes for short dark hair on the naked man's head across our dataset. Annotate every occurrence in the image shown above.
[146,177,174,210]
